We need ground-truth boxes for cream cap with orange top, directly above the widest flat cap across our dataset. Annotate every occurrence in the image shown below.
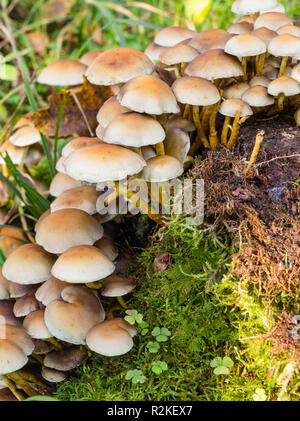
[103,111,165,148]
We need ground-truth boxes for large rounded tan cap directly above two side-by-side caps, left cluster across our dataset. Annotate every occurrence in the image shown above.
[36,207,103,253]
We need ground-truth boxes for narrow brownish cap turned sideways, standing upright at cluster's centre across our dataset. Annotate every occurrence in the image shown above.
[164,128,191,164]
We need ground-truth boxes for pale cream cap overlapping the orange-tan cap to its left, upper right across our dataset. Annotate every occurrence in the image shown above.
[225,34,267,57]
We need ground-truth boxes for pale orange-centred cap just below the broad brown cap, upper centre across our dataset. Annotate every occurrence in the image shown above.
[172,76,220,106]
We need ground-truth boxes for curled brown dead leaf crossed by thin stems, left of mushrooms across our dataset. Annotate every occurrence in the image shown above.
[26,78,113,137]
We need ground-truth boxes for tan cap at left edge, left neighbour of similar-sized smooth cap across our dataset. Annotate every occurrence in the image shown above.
[2,244,55,285]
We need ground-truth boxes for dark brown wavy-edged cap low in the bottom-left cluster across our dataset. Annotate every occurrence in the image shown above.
[43,346,88,371]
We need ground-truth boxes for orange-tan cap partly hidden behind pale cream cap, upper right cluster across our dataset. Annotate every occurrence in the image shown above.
[189,29,232,53]
